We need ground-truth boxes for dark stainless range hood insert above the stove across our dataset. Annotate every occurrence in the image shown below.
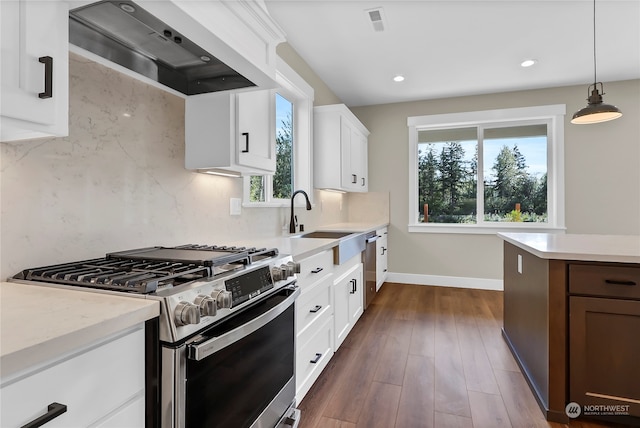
[69,0,256,95]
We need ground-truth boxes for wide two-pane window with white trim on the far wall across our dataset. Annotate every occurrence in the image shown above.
[407,105,565,233]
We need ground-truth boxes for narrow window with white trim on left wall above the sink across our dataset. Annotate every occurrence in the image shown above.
[244,58,313,207]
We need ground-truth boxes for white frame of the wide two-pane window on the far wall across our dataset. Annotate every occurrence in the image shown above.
[407,104,566,234]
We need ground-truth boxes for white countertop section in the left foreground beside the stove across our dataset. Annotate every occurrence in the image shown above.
[0,282,160,378]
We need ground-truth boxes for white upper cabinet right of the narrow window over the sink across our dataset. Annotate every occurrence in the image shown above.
[313,104,369,192]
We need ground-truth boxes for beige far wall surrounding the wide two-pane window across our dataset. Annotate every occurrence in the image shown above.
[352,80,640,282]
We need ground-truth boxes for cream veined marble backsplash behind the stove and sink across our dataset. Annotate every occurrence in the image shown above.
[0,54,372,279]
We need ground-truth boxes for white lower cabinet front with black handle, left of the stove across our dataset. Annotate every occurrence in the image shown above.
[0,325,145,428]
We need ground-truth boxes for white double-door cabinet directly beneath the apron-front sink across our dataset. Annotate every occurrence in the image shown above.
[333,261,364,351]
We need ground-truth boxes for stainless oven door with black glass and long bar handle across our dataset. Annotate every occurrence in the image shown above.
[162,287,300,428]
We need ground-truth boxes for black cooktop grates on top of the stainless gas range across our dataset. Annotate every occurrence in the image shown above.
[14,244,278,294]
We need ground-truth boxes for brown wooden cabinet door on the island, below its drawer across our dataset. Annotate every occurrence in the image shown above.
[569,296,640,423]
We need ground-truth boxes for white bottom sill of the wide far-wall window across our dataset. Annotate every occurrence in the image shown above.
[408,223,566,235]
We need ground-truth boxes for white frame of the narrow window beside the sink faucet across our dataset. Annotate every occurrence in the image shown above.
[242,57,314,208]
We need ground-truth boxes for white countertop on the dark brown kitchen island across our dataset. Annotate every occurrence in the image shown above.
[498,233,640,263]
